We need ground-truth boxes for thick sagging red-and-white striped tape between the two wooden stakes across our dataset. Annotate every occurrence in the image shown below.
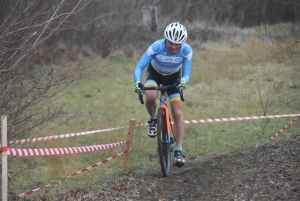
[7,141,126,156]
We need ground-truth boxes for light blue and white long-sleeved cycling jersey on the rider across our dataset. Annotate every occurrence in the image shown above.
[134,39,193,83]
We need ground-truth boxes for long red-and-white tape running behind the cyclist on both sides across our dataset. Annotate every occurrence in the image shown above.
[0,114,300,147]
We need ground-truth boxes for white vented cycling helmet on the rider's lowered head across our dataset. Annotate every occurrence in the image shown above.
[165,22,187,44]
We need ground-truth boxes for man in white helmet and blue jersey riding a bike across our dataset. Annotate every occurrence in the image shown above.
[134,22,193,167]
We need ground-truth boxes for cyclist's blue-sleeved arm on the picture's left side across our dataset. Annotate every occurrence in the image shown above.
[134,41,161,82]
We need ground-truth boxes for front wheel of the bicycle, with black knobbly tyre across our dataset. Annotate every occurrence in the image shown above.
[157,108,171,177]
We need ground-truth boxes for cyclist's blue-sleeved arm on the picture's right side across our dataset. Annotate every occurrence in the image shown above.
[182,45,193,83]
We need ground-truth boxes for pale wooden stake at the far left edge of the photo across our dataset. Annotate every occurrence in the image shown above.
[1,115,8,201]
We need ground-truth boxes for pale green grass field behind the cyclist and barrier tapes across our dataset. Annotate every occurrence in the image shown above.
[11,24,300,199]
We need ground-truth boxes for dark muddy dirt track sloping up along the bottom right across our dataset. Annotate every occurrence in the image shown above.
[29,135,300,201]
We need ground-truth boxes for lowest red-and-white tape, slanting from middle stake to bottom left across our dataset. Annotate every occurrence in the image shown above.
[14,147,131,199]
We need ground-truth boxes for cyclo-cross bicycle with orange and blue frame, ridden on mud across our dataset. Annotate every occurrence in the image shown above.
[139,81,184,177]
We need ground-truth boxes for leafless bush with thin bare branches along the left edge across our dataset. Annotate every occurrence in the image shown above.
[0,0,106,195]
